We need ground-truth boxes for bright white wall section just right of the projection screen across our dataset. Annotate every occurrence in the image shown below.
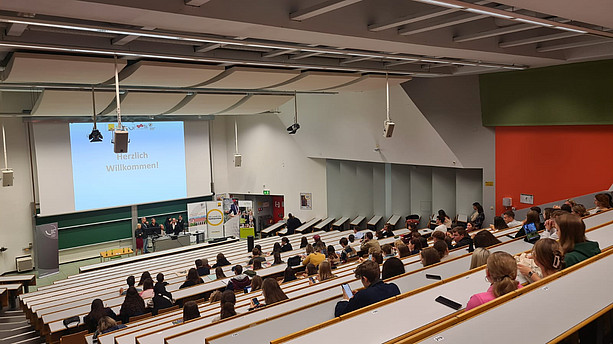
[213,114,327,221]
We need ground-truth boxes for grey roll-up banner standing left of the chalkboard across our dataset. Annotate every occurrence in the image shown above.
[35,222,60,277]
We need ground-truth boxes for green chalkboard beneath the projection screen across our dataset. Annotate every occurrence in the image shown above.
[36,196,212,249]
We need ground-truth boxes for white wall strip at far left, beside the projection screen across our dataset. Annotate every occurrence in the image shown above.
[0,118,33,271]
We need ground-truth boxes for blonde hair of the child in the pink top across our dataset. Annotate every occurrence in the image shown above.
[487,251,519,297]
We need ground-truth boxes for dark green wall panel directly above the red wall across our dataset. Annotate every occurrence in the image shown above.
[479,60,613,126]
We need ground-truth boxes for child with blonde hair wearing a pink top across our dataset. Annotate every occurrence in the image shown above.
[466,251,521,310]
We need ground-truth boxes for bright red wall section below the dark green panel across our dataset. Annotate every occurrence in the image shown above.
[496,125,613,214]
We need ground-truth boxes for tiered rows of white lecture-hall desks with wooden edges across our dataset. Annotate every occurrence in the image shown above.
[14,206,613,344]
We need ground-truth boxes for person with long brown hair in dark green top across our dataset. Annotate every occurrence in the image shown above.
[555,214,600,267]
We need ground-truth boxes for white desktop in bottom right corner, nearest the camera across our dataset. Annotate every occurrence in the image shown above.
[422,250,613,344]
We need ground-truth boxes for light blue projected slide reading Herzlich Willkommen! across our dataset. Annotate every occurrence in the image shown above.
[70,122,187,211]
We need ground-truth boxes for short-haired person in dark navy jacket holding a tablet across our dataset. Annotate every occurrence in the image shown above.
[334,260,400,317]
